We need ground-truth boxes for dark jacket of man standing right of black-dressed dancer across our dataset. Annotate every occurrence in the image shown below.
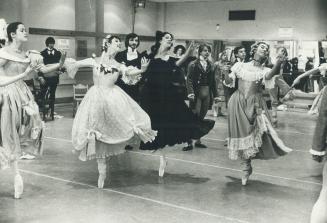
[186,59,218,107]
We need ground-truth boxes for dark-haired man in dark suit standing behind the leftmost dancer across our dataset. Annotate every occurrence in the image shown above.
[37,37,61,120]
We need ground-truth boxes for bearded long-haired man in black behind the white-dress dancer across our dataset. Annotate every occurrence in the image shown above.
[115,33,143,102]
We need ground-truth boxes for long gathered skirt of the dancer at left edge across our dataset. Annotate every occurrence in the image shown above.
[0,81,44,169]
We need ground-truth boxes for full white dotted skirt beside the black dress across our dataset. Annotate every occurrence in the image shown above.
[72,85,156,161]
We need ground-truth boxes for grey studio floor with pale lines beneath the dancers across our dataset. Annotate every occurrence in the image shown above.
[0,106,322,223]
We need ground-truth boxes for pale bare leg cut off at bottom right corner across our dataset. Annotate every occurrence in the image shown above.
[310,162,327,223]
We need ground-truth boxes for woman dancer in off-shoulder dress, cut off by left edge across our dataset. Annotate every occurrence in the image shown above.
[0,22,63,198]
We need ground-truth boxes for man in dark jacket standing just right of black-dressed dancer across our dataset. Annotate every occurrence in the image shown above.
[183,44,218,151]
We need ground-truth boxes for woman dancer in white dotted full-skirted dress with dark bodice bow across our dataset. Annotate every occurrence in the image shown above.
[66,36,156,188]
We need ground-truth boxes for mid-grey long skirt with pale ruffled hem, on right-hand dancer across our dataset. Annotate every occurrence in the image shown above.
[227,91,292,160]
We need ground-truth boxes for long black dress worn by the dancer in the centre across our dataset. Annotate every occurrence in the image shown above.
[140,58,215,150]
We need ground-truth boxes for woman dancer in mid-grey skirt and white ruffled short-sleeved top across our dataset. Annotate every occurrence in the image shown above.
[225,42,291,185]
